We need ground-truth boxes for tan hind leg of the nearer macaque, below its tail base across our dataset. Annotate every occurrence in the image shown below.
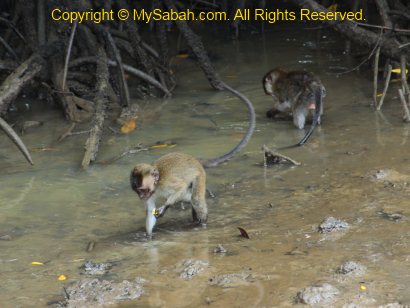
[191,177,208,225]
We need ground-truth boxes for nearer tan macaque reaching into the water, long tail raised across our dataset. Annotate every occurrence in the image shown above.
[130,84,255,237]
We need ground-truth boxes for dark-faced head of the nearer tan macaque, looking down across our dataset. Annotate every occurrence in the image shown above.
[130,164,159,200]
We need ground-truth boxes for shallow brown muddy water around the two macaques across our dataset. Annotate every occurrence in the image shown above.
[0,30,410,307]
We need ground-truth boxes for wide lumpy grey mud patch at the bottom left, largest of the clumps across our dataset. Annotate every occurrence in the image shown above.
[62,277,145,307]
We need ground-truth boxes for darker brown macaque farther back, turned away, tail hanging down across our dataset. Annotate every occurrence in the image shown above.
[263,68,326,146]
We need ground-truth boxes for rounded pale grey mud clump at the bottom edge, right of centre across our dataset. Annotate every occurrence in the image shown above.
[295,283,339,305]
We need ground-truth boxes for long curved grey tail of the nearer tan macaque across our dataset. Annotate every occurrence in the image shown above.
[201,83,255,168]
